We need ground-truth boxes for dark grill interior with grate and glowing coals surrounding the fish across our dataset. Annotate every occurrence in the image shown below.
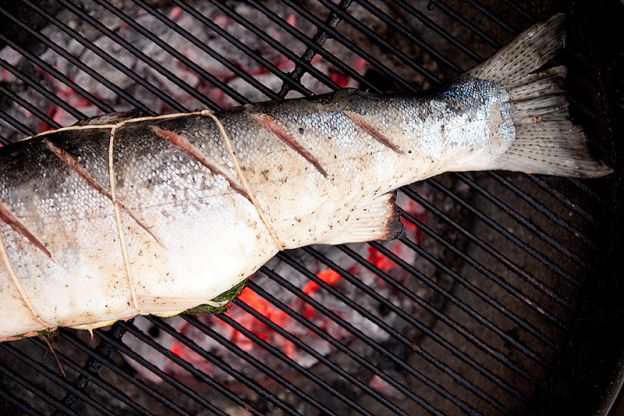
[0,0,621,415]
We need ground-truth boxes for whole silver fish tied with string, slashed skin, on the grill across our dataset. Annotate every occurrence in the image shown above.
[0,15,610,339]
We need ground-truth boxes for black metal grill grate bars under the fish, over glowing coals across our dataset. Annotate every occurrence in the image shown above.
[0,0,606,415]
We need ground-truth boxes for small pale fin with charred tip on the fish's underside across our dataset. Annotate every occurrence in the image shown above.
[322,191,403,244]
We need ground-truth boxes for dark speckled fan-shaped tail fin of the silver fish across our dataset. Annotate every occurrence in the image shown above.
[466,14,612,177]
